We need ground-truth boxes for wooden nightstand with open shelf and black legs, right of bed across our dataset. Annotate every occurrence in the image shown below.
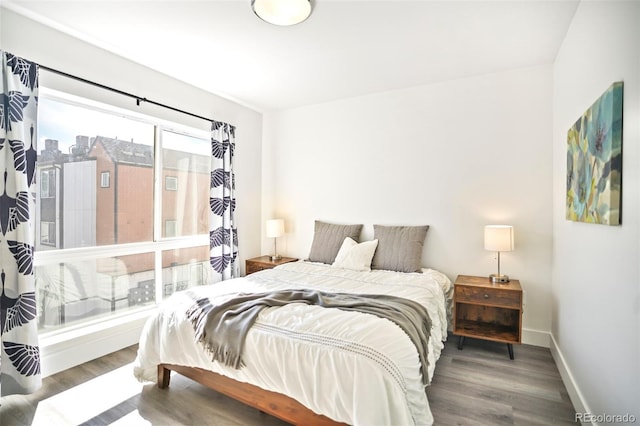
[453,275,522,359]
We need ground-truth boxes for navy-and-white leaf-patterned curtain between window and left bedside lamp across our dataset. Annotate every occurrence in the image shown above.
[209,121,239,280]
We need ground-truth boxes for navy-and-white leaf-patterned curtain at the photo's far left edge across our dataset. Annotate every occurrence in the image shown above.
[0,51,41,396]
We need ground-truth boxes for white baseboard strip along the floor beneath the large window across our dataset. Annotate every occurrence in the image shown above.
[40,311,150,378]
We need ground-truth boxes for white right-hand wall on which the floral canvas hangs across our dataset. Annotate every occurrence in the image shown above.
[552,1,640,421]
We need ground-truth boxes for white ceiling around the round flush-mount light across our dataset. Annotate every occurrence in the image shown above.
[4,0,579,111]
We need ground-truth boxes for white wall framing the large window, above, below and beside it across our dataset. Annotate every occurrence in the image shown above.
[0,7,262,375]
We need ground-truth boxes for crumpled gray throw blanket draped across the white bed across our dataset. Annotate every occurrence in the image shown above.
[187,290,431,384]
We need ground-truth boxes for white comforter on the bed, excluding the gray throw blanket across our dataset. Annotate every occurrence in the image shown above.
[134,262,452,425]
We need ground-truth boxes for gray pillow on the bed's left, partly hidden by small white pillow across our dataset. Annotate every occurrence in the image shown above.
[309,220,362,264]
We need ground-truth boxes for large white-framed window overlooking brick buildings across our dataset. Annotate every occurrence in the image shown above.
[35,88,211,332]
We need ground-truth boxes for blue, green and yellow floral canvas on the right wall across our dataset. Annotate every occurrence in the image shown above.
[567,82,623,225]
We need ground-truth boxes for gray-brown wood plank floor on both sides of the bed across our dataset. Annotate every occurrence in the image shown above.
[0,337,577,426]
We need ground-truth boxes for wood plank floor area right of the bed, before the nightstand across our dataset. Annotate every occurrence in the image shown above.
[427,336,579,426]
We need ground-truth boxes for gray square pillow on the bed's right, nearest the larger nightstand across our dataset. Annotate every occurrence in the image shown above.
[371,225,429,272]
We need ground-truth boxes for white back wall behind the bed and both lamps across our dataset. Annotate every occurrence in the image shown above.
[263,65,552,345]
